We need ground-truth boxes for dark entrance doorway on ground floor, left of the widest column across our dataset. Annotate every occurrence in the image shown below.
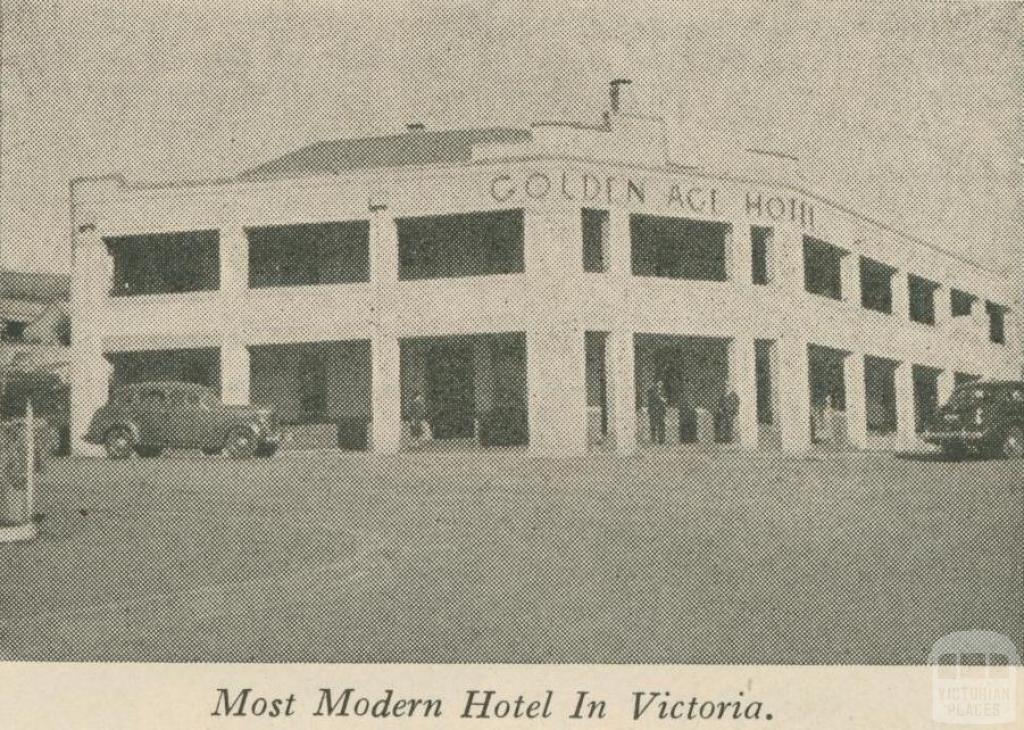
[425,342,476,438]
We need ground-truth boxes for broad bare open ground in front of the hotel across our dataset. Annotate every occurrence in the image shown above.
[0,449,1024,663]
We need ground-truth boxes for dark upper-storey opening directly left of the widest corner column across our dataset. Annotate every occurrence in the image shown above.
[395,210,524,280]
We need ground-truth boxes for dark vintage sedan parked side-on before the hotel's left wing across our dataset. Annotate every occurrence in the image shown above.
[85,382,281,459]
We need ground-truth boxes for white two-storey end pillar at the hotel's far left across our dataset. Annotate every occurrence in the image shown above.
[70,222,114,456]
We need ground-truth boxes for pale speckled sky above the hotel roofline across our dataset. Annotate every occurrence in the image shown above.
[0,0,1024,287]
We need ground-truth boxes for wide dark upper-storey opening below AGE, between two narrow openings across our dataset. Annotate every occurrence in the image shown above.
[630,215,729,282]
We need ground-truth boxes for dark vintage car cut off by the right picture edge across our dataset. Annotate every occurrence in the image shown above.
[922,380,1024,459]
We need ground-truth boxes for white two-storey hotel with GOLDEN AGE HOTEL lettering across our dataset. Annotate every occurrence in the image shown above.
[72,82,1021,455]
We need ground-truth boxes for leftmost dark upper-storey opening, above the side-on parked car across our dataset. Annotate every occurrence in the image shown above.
[103,230,220,297]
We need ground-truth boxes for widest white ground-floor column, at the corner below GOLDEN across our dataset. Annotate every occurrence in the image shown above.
[526,330,587,457]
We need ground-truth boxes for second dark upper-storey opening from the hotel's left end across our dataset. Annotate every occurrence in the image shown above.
[246,220,370,289]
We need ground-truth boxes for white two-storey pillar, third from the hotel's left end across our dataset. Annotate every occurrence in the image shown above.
[370,199,401,454]
